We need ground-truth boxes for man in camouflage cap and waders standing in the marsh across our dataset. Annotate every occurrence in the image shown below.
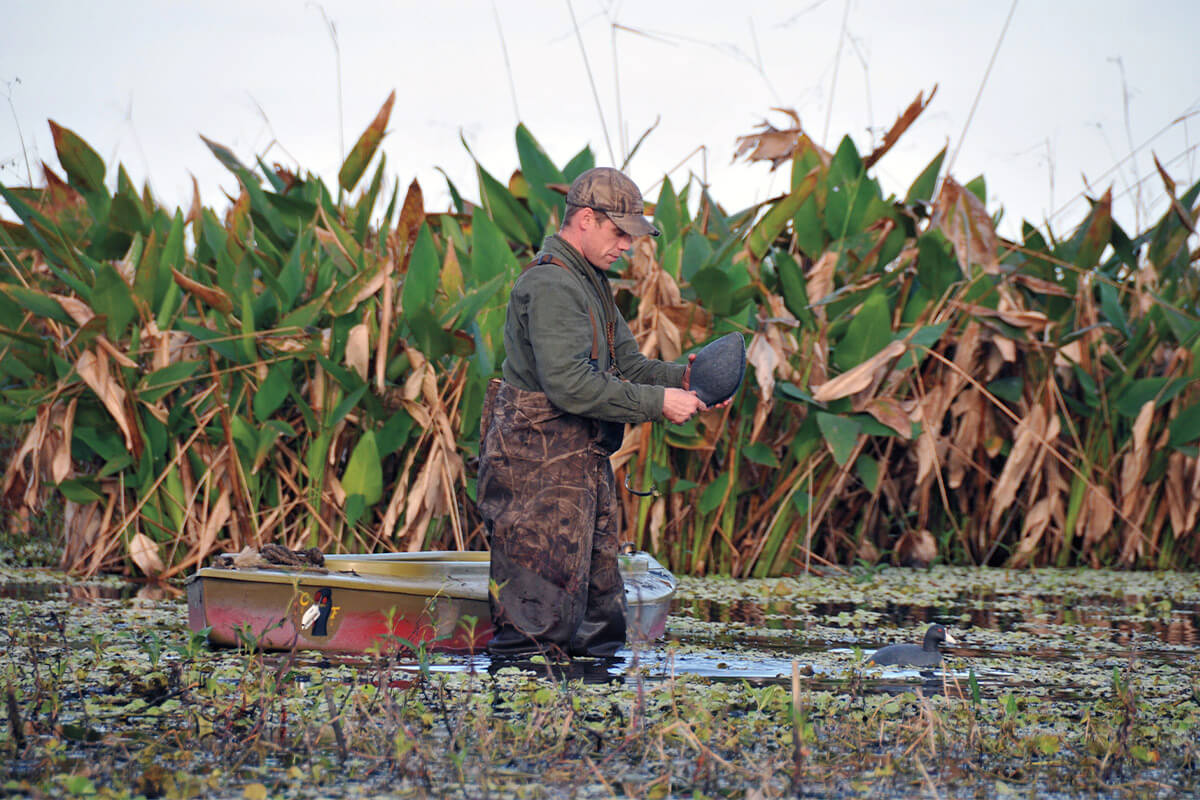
[476,167,704,656]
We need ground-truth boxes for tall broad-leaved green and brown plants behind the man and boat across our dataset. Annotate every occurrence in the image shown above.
[0,95,1200,582]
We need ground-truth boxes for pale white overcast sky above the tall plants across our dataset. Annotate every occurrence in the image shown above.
[0,0,1200,234]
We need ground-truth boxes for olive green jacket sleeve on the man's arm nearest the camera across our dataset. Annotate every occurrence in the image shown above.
[514,265,667,423]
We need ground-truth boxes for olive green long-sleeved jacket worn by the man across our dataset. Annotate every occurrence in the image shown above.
[503,235,684,423]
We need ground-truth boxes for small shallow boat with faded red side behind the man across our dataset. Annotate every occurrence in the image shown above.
[187,551,676,654]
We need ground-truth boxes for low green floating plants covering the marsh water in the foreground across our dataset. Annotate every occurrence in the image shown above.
[0,569,1200,798]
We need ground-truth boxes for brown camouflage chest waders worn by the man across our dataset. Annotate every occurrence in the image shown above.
[476,380,625,655]
